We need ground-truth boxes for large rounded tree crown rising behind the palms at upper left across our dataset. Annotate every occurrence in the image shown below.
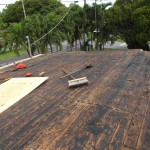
[2,0,63,26]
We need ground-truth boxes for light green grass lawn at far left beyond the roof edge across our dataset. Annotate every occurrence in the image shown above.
[0,50,27,61]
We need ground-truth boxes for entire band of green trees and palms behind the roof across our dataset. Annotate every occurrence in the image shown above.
[0,0,150,53]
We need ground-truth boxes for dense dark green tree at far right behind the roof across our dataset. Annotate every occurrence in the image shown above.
[110,0,150,50]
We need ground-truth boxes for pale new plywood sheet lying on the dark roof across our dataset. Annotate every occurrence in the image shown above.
[0,77,48,113]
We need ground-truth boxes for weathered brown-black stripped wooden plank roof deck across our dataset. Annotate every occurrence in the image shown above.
[0,50,150,150]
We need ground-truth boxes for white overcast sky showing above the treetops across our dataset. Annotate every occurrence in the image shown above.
[0,0,116,12]
